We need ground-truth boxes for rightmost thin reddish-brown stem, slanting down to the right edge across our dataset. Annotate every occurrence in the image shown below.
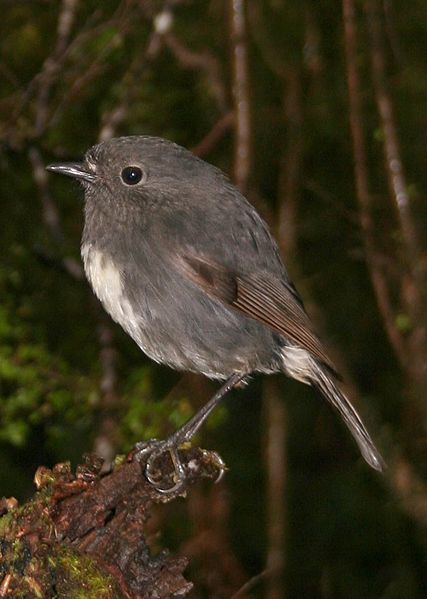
[365,0,427,454]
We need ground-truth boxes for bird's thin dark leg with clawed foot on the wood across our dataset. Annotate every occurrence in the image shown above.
[136,373,246,494]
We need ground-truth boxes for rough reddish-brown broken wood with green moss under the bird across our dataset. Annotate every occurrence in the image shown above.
[0,448,227,599]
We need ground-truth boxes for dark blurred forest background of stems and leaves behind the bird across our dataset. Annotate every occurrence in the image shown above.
[0,0,427,599]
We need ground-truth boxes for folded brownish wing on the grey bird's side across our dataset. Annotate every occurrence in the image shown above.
[177,254,335,372]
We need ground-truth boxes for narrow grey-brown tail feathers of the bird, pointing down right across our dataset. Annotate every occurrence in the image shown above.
[310,363,385,471]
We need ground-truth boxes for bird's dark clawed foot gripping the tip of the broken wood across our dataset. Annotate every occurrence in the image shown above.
[135,436,227,495]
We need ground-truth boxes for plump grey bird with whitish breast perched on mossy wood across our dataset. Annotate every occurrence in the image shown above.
[47,136,384,492]
